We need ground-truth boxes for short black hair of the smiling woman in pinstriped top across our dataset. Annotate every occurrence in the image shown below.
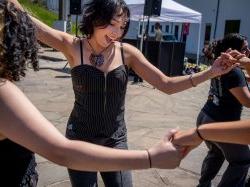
[79,0,130,38]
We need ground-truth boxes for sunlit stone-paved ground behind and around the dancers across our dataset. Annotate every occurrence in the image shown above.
[18,49,250,187]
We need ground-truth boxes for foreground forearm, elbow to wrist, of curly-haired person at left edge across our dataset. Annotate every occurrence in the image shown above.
[57,141,149,171]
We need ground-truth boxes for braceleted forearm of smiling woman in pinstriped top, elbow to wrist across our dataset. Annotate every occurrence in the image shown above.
[160,70,213,94]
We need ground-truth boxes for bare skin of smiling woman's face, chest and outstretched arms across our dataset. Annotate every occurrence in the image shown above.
[4,0,242,171]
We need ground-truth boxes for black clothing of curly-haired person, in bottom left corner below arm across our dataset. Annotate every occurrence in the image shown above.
[0,139,38,187]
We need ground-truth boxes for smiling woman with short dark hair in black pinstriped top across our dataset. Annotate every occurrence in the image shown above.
[9,0,238,187]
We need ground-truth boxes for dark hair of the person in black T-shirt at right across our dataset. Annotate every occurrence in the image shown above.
[205,33,247,59]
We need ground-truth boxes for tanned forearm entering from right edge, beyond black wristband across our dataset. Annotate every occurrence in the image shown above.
[199,120,250,144]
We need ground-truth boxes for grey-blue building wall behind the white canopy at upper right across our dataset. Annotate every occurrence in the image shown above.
[175,0,250,53]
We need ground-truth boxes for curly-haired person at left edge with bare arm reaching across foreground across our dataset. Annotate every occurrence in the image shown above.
[0,0,188,187]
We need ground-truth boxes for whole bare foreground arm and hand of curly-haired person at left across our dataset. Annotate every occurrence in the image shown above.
[0,79,181,171]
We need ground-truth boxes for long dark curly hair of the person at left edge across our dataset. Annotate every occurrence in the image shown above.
[0,0,39,81]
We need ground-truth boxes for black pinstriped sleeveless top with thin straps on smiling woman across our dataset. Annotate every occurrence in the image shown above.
[66,41,128,140]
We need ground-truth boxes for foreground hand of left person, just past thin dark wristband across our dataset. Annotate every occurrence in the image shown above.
[148,130,183,169]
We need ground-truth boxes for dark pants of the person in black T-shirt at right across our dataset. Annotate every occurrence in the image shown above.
[197,112,250,187]
